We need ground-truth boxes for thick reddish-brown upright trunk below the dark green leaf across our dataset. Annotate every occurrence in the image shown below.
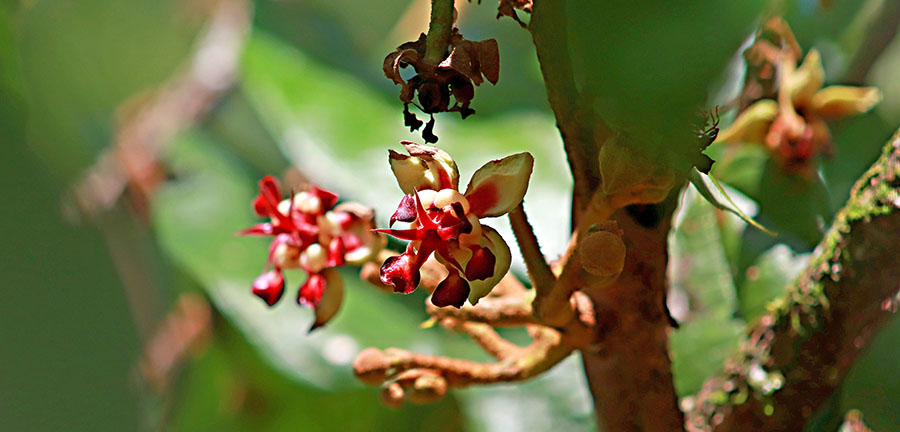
[582,197,684,431]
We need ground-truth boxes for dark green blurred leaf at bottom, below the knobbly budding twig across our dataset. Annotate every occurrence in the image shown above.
[167,323,461,432]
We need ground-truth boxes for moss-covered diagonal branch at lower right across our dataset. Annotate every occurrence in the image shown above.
[688,131,900,431]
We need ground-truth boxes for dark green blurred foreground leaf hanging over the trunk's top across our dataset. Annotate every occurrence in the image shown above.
[566,0,766,157]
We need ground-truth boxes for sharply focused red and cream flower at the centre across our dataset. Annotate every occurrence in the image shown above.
[376,142,534,307]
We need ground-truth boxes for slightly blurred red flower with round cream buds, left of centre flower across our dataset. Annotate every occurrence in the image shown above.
[238,176,385,330]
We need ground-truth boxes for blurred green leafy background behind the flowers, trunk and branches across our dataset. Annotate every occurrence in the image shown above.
[0,0,900,431]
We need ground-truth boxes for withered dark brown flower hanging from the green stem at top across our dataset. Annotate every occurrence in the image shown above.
[383,29,500,143]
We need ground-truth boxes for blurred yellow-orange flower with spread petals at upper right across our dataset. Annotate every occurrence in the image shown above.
[716,19,881,178]
